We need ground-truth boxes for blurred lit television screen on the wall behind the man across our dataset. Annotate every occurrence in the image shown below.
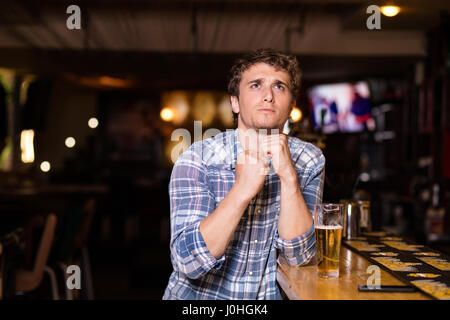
[308,81,373,133]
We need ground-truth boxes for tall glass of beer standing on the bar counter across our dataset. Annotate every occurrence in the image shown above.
[314,203,344,278]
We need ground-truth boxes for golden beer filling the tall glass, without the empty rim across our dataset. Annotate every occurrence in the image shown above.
[315,225,342,278]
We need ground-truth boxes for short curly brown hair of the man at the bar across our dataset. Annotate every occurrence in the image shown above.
[228,49,301,123]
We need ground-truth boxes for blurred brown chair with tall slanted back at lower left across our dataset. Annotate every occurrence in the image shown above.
[15,213,59,300]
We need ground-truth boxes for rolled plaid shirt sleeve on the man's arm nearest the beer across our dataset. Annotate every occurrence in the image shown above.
[275,149,325,265]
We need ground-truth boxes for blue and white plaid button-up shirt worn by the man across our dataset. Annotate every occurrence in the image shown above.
[163,129,325,300]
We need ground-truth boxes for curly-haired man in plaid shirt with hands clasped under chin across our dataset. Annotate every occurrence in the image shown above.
[163,49,325,299]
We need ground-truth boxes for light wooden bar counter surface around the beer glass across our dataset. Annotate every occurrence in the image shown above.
[277,246,430,300]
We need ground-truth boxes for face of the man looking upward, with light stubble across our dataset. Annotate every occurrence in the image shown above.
[231,63,294,132]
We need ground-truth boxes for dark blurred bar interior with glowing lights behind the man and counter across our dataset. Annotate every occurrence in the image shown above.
[0,0,450,299]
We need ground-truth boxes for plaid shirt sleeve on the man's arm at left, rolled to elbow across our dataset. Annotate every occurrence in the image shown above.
[169,149,225,279]
